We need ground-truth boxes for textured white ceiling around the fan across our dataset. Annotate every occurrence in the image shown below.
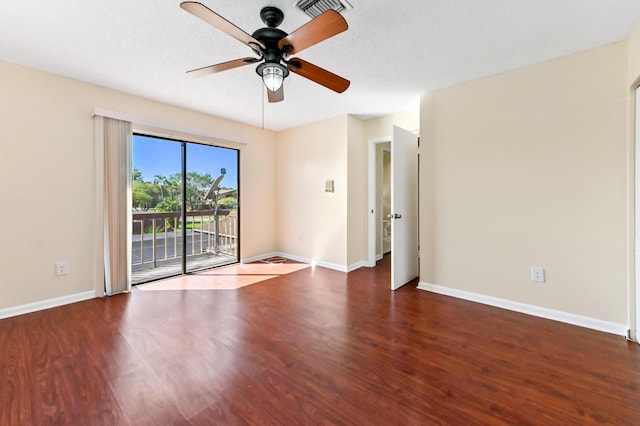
[0,0,640,130]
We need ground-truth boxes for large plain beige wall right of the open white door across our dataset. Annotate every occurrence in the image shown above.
[420,42,628,324]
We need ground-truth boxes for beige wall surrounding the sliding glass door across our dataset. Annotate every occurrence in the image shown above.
[0,62,276,309]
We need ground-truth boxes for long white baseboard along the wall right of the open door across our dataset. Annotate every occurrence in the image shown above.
[418,282,628,337]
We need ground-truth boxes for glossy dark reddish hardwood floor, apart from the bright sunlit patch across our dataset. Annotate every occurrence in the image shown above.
[0,256,640,426]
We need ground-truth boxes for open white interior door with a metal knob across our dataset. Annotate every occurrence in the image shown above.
[390,126,418,290]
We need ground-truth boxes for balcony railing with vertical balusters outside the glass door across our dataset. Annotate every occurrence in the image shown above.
[131,210,238,281]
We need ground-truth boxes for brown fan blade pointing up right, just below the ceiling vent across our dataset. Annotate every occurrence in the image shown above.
[278,10,349,53]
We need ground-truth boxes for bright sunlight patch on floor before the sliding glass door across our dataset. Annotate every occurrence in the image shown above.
[136,263,311,291]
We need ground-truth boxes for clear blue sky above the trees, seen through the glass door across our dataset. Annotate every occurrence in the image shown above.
[133,135,238,188]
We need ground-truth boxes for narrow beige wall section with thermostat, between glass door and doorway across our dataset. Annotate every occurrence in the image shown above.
[277,116,349,268]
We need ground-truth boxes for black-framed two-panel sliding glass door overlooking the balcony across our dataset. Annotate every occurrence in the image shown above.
[131,134,239,285]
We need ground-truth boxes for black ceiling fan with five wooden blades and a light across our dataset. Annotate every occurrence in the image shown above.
[180,1,351,102]
